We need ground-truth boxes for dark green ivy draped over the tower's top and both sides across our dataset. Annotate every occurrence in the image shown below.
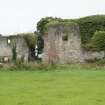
[37,15,105,50]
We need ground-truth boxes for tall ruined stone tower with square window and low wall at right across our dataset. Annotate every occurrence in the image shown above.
[42,23,104,64]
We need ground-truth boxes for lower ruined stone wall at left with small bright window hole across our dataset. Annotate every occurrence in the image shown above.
[0,36,29,62]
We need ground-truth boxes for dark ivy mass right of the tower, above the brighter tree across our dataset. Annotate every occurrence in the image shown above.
[76,15,105,44]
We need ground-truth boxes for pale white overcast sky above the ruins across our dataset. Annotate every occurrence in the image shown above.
[0,0,105,35]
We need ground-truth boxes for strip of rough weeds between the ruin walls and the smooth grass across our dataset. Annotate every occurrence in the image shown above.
[0,59,105,71]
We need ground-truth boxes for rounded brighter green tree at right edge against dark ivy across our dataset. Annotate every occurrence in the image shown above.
[91,31,105,58]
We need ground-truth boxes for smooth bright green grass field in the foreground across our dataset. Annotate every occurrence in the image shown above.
[0,67,105,105]
